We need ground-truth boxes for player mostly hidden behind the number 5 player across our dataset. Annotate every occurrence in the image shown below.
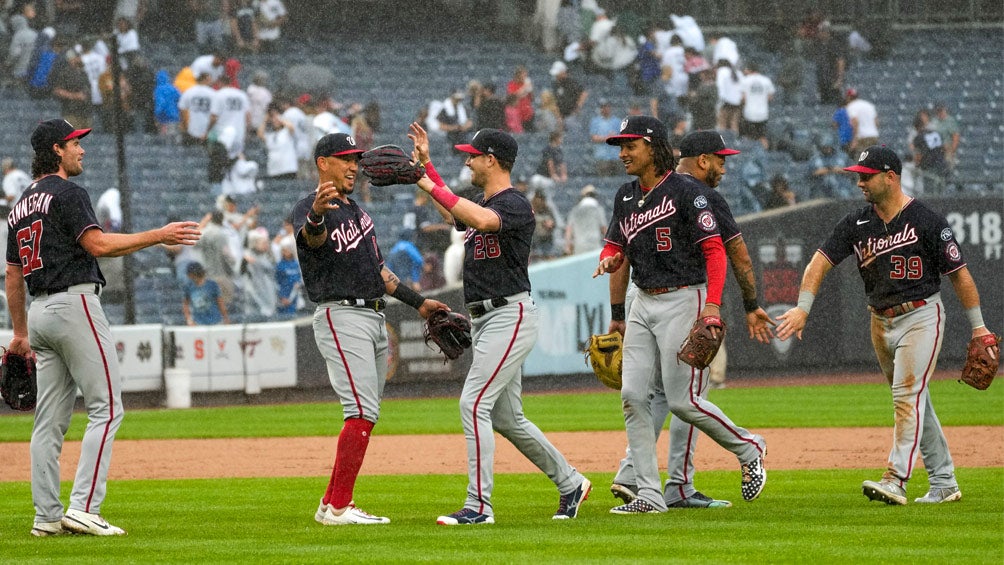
[610,130,775,508]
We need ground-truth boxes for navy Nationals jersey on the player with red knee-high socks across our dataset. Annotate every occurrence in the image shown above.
[293,193,387,303]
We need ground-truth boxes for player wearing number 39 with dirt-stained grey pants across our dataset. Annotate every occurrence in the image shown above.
[777,146,990,505]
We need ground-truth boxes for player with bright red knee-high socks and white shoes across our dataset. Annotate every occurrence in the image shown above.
[292,133,449,526]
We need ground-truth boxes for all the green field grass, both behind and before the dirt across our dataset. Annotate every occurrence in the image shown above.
[0,380,1004,564]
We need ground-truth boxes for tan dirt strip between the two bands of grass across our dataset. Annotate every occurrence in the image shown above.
[0,427,1004,481]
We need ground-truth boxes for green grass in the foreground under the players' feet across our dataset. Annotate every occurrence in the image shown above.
[0,469,1004,565]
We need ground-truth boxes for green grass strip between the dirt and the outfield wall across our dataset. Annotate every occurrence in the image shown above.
[0,380,1004,442]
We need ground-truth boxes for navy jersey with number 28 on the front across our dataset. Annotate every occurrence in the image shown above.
[456,188,536,302]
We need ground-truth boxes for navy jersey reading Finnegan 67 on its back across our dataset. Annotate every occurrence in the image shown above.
[7,175,104,296]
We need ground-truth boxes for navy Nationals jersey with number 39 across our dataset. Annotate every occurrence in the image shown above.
[819,200,966,309]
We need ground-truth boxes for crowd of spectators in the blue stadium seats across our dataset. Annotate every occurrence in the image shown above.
[3,0,983,323]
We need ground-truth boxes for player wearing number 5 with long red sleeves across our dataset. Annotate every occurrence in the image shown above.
[593,115,767,514]
